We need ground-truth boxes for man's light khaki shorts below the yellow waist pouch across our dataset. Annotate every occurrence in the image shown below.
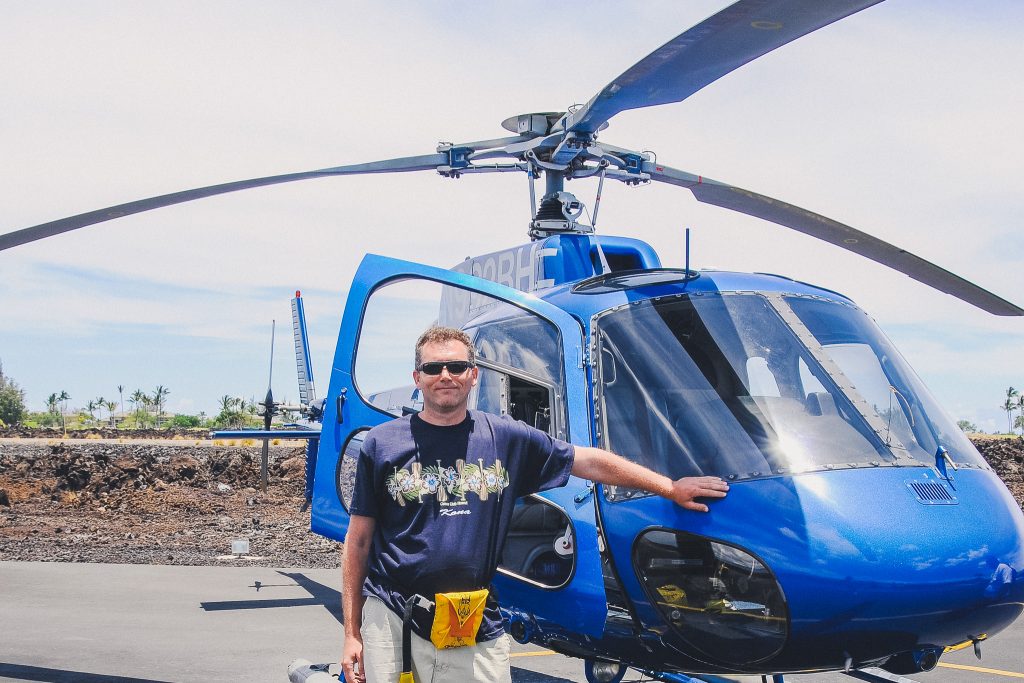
[360,596,512,683]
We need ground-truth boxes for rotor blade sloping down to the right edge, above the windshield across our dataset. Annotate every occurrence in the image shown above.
[643,162,1024,315]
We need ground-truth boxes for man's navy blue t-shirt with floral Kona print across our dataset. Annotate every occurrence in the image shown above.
[349,411,574,641]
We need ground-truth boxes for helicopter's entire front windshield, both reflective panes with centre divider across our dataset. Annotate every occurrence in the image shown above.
[596,294,985,499]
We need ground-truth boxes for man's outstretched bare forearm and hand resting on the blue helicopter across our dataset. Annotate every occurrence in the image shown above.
[572,445,729,512]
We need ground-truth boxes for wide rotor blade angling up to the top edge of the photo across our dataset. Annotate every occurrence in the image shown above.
[565,0,881,133]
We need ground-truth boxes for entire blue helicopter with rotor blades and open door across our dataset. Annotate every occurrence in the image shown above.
[0,1,1024,681]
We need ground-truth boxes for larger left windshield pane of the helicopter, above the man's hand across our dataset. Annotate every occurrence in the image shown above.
[595,294,897,500]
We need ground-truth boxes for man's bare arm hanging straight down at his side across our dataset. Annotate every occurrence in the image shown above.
[341,515,377,683]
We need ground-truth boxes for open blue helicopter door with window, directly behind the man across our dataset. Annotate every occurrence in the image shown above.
[312,255,606,636]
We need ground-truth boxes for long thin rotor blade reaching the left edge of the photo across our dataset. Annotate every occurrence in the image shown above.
[0,154,449,251]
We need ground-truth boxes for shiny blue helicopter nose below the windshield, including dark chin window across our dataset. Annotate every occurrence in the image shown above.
[632,467,1024,673]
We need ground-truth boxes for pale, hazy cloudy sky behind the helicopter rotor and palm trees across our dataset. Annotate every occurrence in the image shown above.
[0,0,1024,431]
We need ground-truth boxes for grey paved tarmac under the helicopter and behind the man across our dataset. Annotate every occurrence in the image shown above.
[0,562,1024,683]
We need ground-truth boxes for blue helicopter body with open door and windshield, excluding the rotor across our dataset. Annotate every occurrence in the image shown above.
[312,236,1024,673]
